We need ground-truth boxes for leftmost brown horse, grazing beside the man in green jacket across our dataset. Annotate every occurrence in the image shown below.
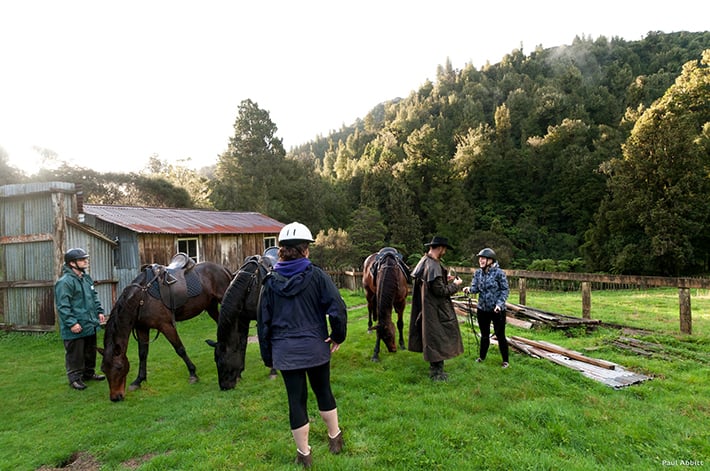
[99,262,232,401]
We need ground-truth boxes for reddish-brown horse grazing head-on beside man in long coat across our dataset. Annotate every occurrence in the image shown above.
[362,247,409,361]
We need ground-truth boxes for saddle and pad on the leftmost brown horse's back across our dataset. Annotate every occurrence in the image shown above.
[148,252,202,311]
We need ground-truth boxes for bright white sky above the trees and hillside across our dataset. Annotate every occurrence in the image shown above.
[0,0,710,174]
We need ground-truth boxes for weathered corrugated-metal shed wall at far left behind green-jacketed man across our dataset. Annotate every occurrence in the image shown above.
[0,182,116,331]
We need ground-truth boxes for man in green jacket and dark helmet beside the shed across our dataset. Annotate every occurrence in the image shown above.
[54,248,106,391]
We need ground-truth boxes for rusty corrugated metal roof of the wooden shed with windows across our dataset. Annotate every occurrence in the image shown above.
[84,204,284,234]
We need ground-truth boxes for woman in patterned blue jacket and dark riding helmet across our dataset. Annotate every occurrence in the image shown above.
[463,248,510,368]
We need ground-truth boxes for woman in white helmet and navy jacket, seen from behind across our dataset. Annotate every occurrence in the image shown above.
[257,222,348,467]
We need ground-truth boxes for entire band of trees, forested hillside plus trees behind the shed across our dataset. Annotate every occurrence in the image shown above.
[5,32,710,275]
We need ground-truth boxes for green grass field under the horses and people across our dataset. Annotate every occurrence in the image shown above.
[0,290,710,470]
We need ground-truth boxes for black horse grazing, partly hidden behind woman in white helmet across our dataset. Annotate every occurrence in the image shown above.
[205,255,276,391]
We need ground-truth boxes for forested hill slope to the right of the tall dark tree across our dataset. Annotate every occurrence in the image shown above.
[278,32,710,274]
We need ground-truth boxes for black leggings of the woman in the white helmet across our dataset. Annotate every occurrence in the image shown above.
[281,362,336,430]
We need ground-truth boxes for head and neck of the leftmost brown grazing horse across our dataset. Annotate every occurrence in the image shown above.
[100,283,143,402]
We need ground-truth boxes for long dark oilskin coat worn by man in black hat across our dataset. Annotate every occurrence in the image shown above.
[409,255,463,363]
